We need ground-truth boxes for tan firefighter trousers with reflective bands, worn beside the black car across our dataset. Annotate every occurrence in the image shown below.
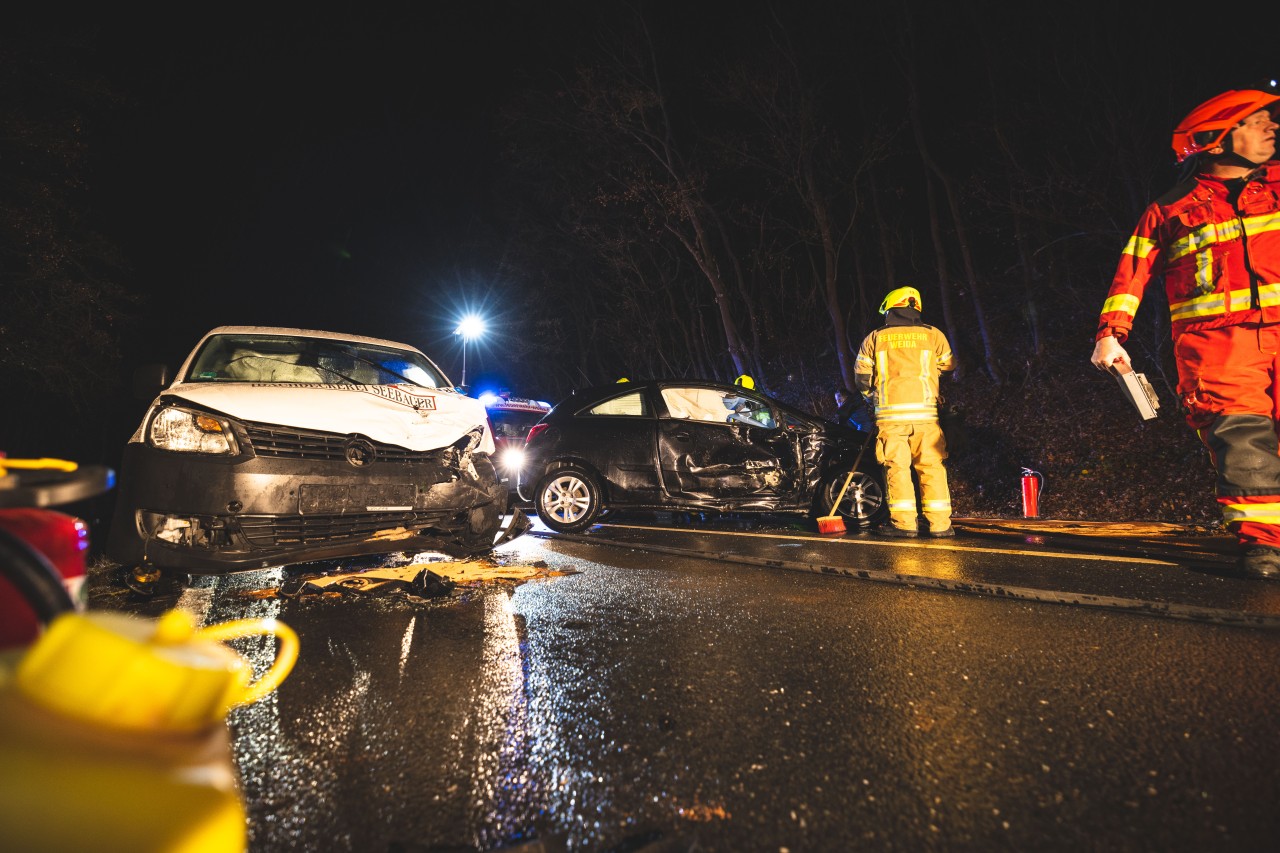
[876,421,951,530]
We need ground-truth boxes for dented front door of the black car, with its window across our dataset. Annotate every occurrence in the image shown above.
[658,384,804,508]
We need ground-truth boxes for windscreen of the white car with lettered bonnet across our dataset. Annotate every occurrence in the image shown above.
[184,334,447,388]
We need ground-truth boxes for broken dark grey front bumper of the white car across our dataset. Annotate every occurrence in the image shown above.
[106,443,529,574]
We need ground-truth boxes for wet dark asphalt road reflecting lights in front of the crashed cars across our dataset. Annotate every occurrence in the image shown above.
[91,517,1280,852]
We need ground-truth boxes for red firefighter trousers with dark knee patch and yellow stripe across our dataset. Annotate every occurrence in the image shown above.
[1174,323,1280,548]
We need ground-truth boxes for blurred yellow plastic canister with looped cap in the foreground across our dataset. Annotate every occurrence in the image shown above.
[0,611,298,853]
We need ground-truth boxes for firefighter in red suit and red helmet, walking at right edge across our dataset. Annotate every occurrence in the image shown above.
[1092,81,1280,580]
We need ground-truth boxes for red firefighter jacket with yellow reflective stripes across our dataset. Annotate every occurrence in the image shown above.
[1096,160,1280,343]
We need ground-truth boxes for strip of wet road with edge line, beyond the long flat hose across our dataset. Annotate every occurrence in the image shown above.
[573,520,1280,629]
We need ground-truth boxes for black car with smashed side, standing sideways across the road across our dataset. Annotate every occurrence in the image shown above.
[518,379,887,533]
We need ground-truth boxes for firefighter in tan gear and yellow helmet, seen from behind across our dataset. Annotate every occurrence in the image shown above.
[854,287,955,537]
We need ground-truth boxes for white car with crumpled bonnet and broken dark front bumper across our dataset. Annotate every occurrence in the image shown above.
[106,327,529,592]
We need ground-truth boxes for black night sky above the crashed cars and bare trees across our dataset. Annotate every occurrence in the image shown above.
[15,1,1274,389]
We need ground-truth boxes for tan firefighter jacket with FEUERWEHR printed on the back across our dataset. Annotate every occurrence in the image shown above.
[854,317,955,424]
